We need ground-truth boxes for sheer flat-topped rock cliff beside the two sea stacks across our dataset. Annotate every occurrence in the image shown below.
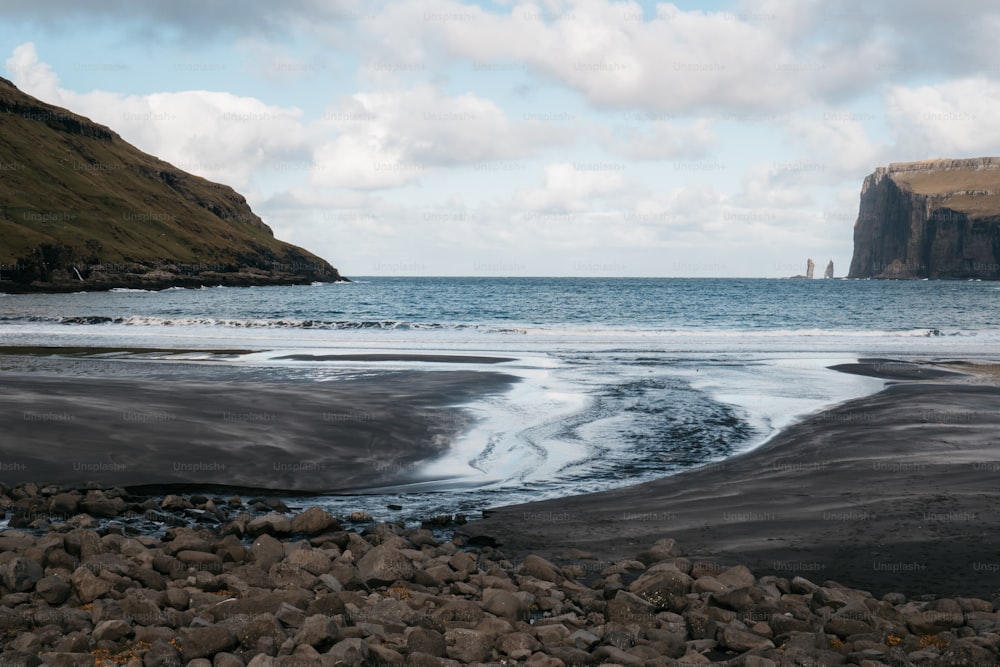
[848,157,1000,280]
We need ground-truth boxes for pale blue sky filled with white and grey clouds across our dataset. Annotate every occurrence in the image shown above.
[0,0,1000,278]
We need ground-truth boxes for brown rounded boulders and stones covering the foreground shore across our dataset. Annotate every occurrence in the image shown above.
[0,483,1000,667]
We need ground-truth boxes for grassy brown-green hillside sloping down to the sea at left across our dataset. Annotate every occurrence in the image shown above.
[0,78,343,292]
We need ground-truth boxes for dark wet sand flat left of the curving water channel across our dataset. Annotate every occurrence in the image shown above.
[0,366,517,494]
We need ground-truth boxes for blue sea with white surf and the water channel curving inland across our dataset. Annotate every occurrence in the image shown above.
[0,277,1000,521]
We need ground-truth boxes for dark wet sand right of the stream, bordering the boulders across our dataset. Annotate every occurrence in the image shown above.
[462,360,1000,598]
